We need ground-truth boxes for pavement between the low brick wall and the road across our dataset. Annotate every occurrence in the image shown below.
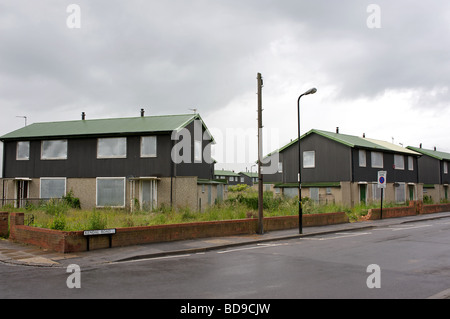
[0,212,450,270]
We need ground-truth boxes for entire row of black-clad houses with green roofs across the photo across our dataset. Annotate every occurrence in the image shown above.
[0,110,450,211]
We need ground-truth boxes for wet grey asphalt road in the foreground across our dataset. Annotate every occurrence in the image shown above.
[0,218,450,299]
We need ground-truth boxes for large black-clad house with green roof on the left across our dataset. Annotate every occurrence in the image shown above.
[0,112,223,209]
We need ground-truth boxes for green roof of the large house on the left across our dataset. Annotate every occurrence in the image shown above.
[0,114,213,140]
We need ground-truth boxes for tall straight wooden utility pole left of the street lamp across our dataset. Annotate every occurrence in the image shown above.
[257,73,264,235]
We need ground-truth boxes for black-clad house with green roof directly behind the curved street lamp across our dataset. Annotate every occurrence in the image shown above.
[264,129,423,206]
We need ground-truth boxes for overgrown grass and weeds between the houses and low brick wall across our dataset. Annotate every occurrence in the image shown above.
[5,190,402,231]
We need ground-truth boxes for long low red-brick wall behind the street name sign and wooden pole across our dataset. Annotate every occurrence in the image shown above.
[6,213,348,253]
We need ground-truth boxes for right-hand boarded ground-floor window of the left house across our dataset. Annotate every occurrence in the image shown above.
[97,177,125,207]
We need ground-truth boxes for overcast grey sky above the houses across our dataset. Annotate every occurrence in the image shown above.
[0,0,450,174]
